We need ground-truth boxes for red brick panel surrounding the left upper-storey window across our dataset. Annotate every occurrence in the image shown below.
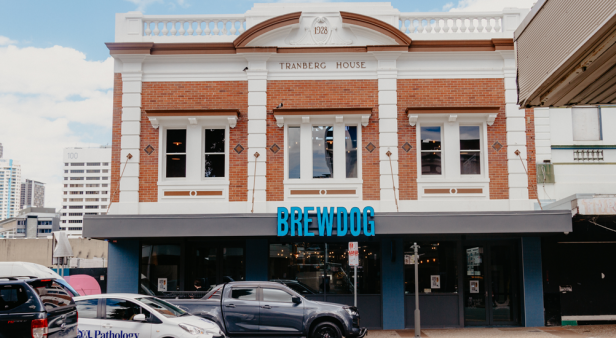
[139,81,248,202]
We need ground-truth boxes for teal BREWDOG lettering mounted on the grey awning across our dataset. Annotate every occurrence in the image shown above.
[277,207,374,237]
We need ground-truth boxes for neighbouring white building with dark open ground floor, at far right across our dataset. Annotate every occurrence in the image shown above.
[534,106,616,325]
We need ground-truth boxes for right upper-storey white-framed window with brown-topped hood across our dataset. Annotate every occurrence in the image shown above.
[407,107,504,199]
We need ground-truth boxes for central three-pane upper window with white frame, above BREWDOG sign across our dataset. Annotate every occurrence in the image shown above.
[274,108,372,198]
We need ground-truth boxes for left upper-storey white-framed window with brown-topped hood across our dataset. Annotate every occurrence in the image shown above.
[144,109,239,201]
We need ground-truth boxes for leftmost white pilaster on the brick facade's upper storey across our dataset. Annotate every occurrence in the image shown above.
[118,55,145,214]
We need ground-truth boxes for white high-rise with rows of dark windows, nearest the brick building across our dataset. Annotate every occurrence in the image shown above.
[60,146,111,237]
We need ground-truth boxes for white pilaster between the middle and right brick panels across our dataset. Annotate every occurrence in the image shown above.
[374,52,400,211]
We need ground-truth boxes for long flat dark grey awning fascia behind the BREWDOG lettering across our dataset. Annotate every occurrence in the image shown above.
[83,210,571,239]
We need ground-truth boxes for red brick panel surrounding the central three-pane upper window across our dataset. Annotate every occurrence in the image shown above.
[266,80,380,201]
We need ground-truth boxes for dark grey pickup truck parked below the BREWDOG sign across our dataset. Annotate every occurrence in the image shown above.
[167,282,368,338]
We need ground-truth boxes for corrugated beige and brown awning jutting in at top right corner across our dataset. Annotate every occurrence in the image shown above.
[515,0,616,108]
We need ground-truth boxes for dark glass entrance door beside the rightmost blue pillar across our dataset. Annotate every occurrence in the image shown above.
[464,243,519,326]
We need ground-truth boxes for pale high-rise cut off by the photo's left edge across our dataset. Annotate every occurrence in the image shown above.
[0,159,21,220]
